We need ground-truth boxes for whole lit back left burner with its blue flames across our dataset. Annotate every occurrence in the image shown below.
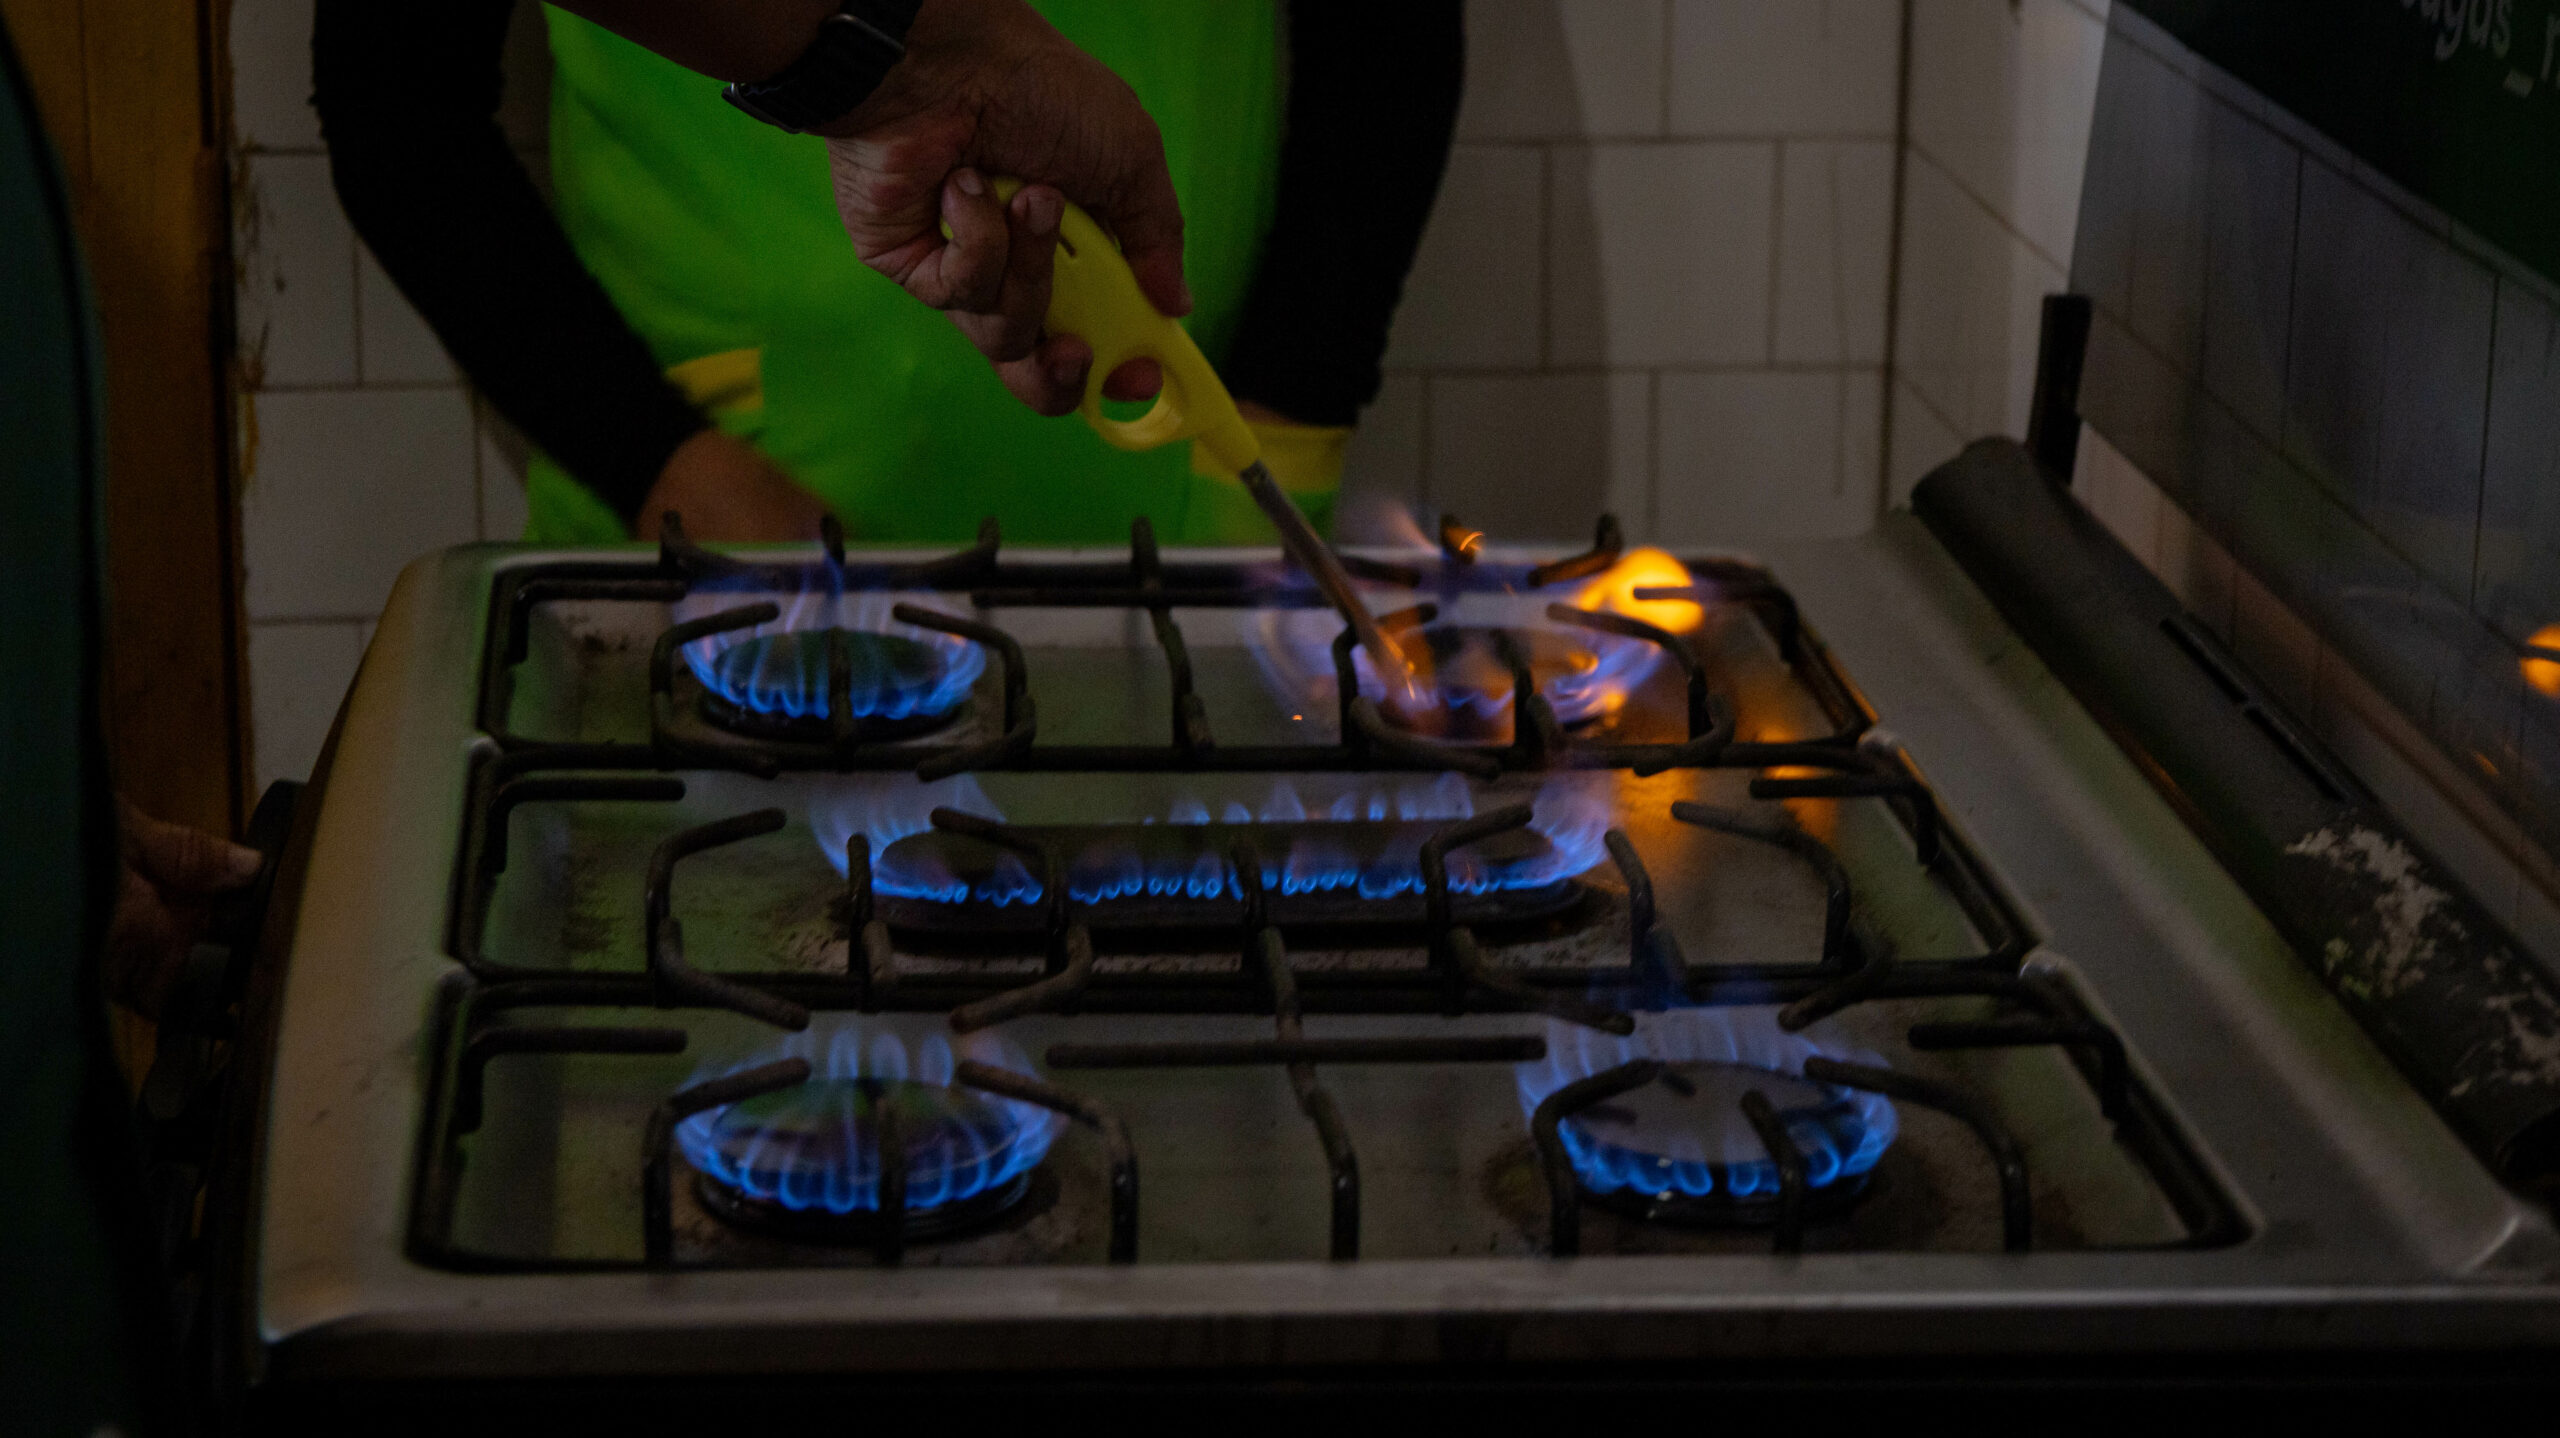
[678,591,986,739]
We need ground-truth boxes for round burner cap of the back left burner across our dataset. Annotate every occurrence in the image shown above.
[689,629,986,739]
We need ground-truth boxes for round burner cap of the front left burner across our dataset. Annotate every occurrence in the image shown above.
[678,1077,1055,1244]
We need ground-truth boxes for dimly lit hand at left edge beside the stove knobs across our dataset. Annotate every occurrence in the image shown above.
[108,798,266,1018]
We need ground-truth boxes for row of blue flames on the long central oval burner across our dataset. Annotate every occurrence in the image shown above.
[809,775,1610,908]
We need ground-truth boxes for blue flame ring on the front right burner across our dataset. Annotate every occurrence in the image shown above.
[1513,1008,1900,1197]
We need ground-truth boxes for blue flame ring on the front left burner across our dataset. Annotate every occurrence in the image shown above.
[676,1016,1062,1215]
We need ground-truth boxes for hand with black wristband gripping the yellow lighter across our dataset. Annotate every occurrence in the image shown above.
[822,0,1190,415]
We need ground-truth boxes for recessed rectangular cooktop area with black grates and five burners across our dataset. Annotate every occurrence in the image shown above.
[410,511,2232,1269]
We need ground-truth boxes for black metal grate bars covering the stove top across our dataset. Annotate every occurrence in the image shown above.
[412,509,2225,1269]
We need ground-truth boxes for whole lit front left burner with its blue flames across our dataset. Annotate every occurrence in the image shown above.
[676,1018,1060,1241]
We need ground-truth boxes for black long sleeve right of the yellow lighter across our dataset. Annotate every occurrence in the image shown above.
[1226,0,1467,425]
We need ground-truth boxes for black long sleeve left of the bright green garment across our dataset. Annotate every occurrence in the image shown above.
[312,0,707,525]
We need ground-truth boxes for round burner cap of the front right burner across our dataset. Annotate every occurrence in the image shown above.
[1562,1062,1892,1223]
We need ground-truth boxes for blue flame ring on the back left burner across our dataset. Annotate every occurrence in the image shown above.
[676,568,986,719]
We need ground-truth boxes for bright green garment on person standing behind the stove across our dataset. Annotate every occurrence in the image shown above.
[527,0,1280,542]
